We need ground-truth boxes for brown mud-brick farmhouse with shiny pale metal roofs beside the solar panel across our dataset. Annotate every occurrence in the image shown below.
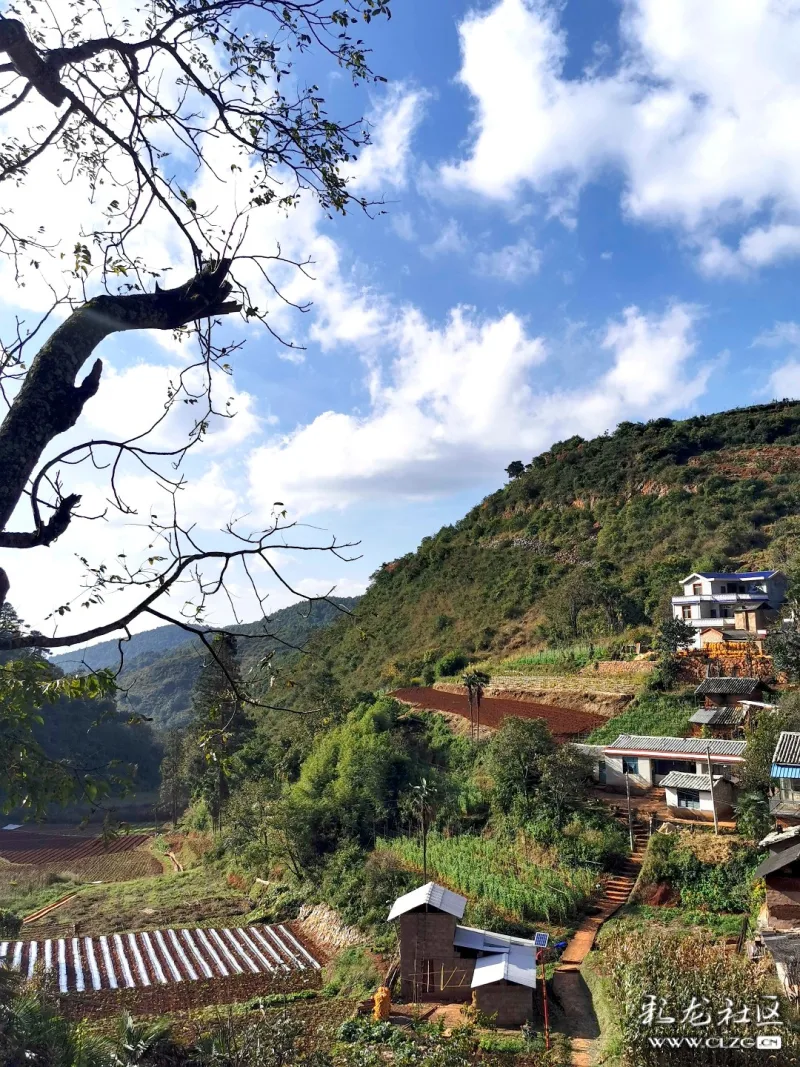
[388,881,537,1026]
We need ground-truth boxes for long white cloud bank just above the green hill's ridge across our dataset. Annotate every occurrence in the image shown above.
[250,304,710,513]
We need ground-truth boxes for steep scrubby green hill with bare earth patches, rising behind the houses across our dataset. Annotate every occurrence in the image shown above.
[288,401,800,687]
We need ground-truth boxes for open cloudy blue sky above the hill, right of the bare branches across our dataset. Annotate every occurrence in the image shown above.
[6,0,800,621]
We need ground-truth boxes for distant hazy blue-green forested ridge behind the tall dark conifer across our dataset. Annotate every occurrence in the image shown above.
[53,596,358,729]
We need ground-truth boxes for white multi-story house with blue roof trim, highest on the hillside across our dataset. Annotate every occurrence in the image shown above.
[672,571,787,648]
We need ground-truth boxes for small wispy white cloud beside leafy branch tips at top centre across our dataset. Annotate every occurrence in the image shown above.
[350,83,428,193]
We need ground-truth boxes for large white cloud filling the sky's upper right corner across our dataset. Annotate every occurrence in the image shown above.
[439,0,800,274]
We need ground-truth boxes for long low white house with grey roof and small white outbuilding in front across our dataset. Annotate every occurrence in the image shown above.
[596,734,745,819]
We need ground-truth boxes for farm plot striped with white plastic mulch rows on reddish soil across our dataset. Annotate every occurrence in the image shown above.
[0,925,320,993]
